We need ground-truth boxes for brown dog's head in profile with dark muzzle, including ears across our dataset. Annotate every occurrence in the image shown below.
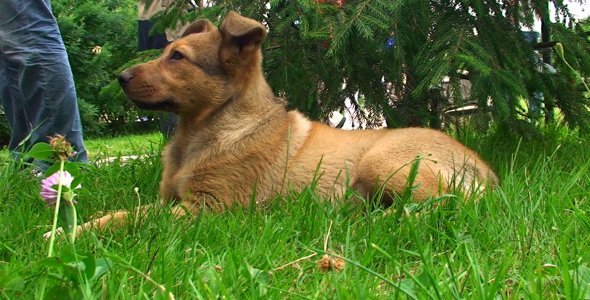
[119,12,266,114]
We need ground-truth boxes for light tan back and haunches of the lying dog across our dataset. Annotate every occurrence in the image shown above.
[288,113,498,200]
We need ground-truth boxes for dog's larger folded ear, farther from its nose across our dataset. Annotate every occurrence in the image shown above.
[219,11,266,64]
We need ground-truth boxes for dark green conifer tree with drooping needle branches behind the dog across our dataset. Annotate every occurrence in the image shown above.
[159,0,590,130]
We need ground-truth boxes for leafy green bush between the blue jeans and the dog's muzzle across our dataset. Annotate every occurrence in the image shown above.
[52,0,157,135]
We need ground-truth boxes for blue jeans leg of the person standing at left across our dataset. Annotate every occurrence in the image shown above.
[0,0,88,162]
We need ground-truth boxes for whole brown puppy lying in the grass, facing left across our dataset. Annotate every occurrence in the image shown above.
[86,12,497,227]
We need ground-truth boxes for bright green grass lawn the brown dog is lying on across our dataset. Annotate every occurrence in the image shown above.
[0,133,590,299]
